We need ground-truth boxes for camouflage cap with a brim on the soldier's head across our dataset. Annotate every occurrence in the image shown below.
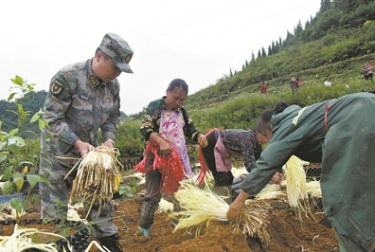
[99,33,134,73]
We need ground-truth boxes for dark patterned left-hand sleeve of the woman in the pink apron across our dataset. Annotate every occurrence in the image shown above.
[140,100,161,141]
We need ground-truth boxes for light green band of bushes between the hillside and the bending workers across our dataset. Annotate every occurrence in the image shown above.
[189,77,373,135]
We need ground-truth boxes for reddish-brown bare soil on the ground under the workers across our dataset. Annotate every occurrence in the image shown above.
[0,163,339,252]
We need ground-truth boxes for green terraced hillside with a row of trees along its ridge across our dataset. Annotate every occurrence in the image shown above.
[186,0,375,111]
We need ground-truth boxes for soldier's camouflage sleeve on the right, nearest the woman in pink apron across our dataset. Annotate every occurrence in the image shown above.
[100,79,120,142]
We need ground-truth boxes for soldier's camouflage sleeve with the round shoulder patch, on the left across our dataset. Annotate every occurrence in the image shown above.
[43,72,78,153]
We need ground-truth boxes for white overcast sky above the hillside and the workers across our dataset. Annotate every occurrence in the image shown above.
[0,0,320,115]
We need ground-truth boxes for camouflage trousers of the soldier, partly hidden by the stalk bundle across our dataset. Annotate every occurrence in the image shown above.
[39,152,118,238]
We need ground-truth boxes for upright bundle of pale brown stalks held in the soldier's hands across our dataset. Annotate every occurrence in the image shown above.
[66,146,122,219]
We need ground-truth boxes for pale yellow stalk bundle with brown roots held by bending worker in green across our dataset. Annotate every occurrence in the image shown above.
[169,181,271,244]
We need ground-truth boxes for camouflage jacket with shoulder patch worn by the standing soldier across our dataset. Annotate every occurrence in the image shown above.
[42,60,120,156]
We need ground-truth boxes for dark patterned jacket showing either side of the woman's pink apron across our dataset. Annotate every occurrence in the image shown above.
[140,96,199,143]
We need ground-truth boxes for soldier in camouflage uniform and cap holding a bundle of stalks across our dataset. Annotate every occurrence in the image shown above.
[40,33,133,252]
